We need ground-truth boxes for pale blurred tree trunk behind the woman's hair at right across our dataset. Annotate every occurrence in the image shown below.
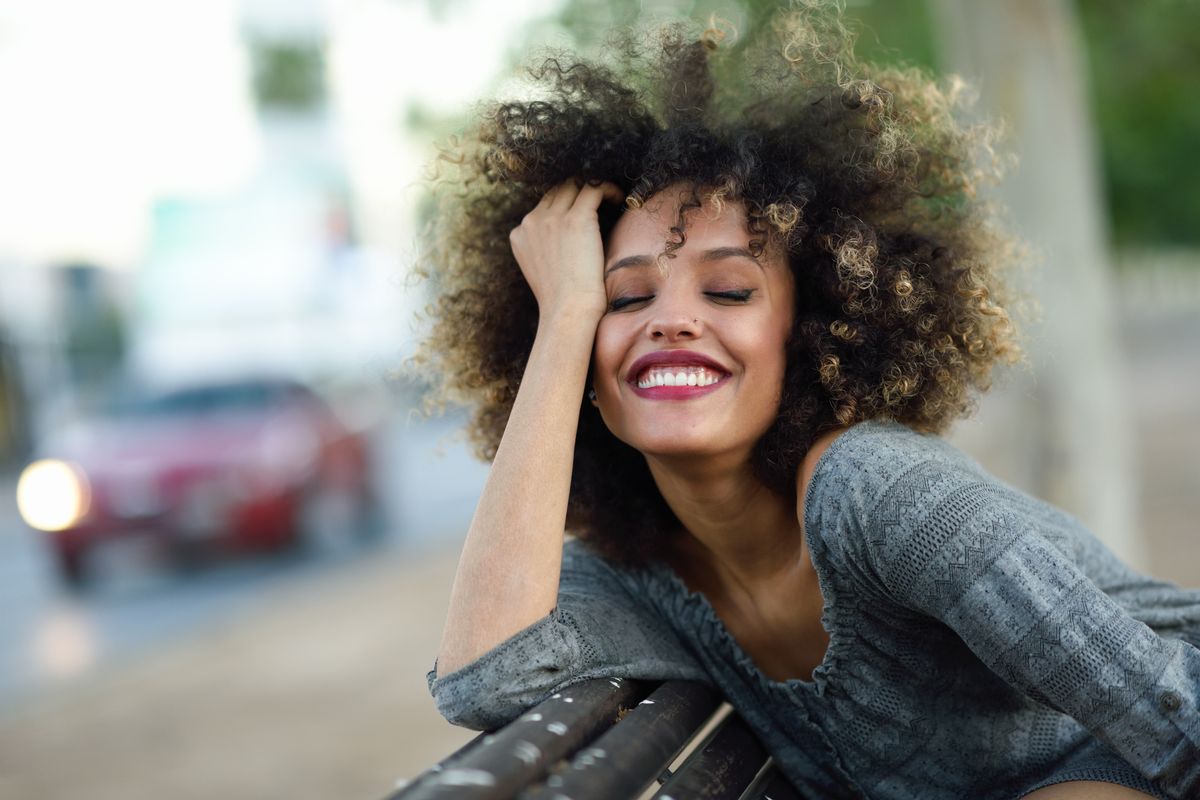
[931,0,1146,566]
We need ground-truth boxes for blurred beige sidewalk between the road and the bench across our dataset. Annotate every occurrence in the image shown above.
[0,548,473,800]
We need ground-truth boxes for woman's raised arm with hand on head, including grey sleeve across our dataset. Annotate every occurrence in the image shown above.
[428,181,706,729]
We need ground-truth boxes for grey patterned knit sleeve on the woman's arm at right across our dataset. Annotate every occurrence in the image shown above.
[825,434,1200,799]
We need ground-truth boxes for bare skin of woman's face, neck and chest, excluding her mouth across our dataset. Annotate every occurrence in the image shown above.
[593,187,828,680]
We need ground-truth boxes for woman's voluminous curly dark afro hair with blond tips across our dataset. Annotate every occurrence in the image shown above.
[420,1,1018,564]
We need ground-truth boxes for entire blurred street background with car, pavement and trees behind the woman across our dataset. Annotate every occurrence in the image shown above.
[0,0,1200,800]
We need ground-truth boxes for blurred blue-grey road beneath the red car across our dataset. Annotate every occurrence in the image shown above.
[0,407,486,718]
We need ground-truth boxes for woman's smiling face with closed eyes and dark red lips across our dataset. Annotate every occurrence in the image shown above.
[593,187,793,459]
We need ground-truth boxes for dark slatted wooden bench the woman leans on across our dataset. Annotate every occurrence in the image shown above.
[386,678,799,800]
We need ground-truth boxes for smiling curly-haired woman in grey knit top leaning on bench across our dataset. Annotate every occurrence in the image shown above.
[417,4,1200,800]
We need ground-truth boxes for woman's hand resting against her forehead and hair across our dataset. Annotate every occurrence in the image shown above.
[509,178,624,319]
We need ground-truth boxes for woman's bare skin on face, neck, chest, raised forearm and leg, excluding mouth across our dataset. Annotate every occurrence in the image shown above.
[438,181,1150,800]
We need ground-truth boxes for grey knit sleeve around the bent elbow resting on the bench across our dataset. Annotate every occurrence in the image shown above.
[427,542,708,730]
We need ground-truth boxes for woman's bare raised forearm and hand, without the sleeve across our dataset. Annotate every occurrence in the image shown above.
[438,180,622,674]
